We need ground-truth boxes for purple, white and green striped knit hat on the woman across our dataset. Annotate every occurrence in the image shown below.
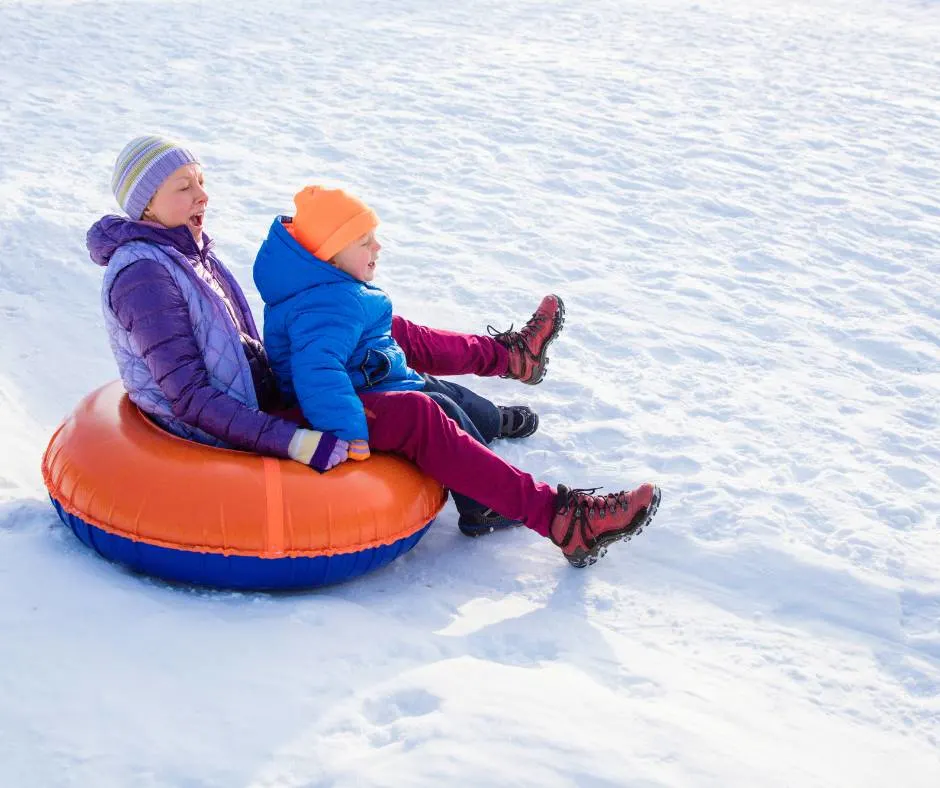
[111,136,198,221]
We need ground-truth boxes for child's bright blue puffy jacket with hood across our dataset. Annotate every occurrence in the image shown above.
[254,217,424,440]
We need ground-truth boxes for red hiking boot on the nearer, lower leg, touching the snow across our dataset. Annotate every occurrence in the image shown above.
[548,484,660,568]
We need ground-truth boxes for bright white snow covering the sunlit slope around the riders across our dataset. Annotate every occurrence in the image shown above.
[0,0,940,788]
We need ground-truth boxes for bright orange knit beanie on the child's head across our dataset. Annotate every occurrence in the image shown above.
[290,186,379,260]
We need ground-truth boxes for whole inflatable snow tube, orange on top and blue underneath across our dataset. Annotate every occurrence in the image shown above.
[42,381,446,589]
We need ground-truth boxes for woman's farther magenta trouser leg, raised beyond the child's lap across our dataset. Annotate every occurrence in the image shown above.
[392,315,509,377]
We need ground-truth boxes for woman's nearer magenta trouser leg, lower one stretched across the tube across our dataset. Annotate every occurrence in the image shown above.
[359,391,556,536]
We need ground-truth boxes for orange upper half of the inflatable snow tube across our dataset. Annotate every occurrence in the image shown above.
[42,381,446,558]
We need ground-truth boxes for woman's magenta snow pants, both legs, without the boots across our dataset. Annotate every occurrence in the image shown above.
[359,316,555,536]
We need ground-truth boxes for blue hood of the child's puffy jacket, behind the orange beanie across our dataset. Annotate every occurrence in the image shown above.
[253,217,358,304]
